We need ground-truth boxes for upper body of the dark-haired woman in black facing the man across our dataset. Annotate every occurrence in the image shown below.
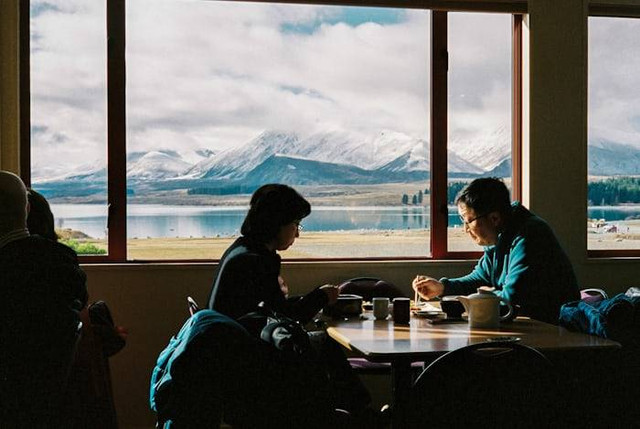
[208,184,338,323]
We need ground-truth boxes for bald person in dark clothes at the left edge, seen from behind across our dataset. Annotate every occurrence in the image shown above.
[0,171,87,427]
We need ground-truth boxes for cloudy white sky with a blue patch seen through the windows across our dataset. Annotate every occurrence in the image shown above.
[31,0,640,177]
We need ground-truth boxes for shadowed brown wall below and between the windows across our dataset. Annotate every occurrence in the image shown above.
[0,0,640,428]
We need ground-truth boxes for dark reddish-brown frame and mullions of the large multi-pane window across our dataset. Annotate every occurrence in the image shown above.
[20,0,527,264]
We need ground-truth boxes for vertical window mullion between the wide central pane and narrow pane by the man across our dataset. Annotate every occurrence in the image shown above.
[430,11,448,259]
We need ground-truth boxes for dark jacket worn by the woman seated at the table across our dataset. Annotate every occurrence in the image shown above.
[208,237,327,323]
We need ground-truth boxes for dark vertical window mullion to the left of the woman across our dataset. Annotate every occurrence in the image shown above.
[107,0,127,262]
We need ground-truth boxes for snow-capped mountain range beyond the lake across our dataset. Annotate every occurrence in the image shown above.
[32,127,640,197]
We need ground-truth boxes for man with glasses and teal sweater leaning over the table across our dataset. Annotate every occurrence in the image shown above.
[413,178,580,324]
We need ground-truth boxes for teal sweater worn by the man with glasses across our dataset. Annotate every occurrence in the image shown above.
[440,202,580,324]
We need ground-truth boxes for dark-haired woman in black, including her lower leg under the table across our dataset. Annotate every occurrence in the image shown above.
[208,184,377,422]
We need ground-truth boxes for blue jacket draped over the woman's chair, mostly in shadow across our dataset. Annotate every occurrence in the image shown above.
[150,310,335,429]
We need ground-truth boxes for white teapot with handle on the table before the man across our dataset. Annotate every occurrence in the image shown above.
[458,286,513,328]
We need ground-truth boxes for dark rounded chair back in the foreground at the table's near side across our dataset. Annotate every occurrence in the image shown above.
[407,342,560,428]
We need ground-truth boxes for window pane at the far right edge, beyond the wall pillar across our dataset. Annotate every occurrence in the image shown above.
[587,18,640,250]
